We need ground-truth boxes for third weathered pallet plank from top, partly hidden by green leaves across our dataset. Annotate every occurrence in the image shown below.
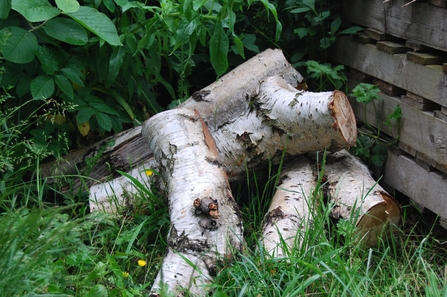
[350,89,447,170]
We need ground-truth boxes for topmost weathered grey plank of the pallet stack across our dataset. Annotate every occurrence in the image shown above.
[342,0,447,51]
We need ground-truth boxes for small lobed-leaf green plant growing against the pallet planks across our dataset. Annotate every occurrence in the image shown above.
[351,83,402,167]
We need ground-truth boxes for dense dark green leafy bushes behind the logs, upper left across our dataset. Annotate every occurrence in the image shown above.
[0,0,281,169]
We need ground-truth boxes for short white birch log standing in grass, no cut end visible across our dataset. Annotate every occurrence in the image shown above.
[262,157,316,257]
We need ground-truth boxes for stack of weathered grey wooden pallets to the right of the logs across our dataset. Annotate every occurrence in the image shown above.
[333,0,447,227]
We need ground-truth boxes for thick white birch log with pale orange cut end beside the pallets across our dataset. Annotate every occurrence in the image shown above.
[212,76,357,177]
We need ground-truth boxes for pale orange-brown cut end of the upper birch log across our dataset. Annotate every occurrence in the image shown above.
[331,90,357,148]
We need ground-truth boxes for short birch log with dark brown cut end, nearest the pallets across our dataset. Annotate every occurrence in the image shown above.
[325,150,400,247]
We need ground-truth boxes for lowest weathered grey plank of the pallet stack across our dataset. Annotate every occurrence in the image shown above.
[383,150,447,219]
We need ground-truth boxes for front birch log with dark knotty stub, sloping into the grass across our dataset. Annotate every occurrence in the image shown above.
[145,109,243,296]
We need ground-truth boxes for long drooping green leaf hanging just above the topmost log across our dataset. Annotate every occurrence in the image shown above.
[210,22,229,76]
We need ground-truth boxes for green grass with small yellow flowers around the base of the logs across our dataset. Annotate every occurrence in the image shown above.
[0,156,447,297]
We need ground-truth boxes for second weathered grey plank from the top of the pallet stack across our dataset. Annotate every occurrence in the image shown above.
[332,35,447,106]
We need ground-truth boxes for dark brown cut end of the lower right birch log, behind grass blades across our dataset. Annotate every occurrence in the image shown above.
[357,191,400,247]
